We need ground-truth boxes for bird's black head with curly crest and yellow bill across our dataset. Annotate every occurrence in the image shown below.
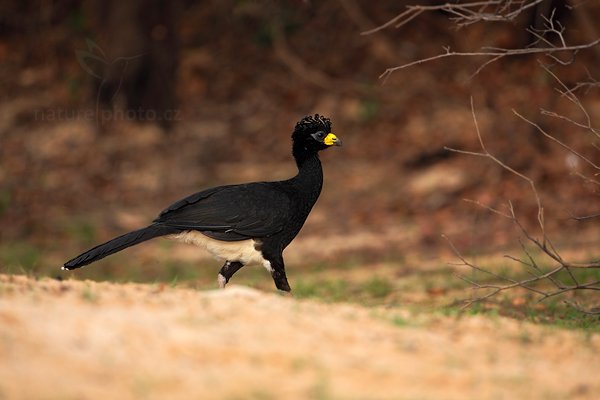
[292,114,342,153]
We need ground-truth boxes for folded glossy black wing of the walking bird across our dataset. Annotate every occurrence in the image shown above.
[154,182,292,241]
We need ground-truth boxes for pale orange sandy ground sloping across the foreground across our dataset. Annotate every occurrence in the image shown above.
[0,275,600,399]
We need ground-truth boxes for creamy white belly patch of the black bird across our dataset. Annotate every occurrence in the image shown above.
[169,231,271,271]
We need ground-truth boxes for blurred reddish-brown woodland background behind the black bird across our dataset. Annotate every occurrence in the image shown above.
[0,0,600,287]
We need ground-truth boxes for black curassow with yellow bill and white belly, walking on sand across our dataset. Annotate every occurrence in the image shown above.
[62,114,342,292]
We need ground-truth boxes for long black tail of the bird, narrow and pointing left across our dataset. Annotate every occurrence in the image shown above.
[62,225,181,270]
